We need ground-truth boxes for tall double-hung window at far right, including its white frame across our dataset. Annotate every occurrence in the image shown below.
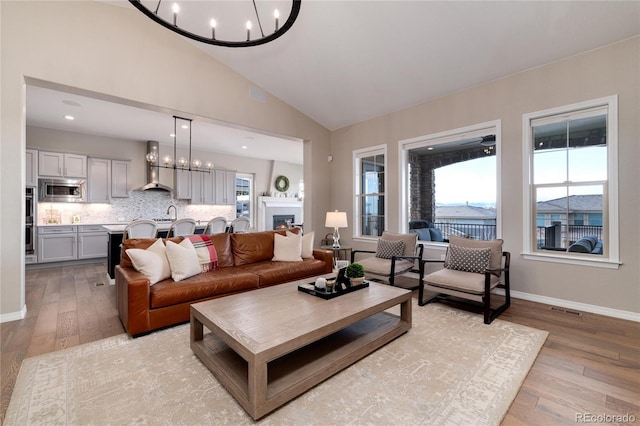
[523,97,618,264]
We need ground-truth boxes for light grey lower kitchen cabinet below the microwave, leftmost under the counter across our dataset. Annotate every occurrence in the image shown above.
[37,226,78,263]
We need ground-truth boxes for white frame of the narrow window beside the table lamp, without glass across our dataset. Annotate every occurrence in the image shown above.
[352,144,389,241]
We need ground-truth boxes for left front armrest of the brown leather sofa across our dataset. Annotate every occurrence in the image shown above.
[115,265,151,336]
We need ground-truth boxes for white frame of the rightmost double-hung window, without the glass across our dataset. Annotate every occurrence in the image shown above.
[522,95,620,269]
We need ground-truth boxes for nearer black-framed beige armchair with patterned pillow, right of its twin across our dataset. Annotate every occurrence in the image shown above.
[418,236,511,324]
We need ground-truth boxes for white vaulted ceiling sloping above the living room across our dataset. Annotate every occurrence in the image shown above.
[27,0,640,162]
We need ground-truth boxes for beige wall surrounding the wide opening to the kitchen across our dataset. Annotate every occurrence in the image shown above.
[0,1,330,321]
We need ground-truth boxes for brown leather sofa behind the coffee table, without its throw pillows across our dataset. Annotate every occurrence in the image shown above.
[115,231,333,336]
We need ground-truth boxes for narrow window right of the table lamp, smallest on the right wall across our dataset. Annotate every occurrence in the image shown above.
[353,145,387,237]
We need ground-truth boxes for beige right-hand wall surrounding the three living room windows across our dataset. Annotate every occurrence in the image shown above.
[331,37,640,318]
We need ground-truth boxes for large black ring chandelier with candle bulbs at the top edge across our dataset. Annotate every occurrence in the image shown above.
[129,0,301,47]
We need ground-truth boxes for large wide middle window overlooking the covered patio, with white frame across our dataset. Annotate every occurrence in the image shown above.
[400,120,501,241]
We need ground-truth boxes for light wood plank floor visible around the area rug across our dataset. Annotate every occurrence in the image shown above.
[0,263,640,426]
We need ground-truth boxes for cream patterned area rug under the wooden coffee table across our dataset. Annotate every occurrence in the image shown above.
[5,299,548,426]
